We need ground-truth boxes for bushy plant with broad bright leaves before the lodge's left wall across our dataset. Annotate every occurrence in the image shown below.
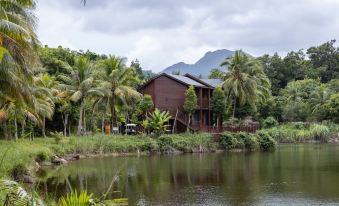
[148,108,171,136]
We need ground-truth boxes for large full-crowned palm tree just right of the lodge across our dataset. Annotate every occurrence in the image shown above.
[221,50,270,117]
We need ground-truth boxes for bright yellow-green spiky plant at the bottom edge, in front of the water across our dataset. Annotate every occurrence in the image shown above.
[58,190,95,206]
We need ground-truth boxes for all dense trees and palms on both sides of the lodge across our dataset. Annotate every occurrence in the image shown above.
[0,0,339,139]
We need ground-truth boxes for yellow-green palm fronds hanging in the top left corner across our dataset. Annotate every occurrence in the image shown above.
[0,0,38,69]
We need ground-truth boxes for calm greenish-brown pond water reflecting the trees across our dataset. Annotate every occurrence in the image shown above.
[40,145,339,205]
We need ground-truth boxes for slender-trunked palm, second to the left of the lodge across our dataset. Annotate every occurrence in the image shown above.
[59,57,103,135]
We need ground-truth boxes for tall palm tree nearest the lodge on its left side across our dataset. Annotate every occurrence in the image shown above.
[97,56,142,129]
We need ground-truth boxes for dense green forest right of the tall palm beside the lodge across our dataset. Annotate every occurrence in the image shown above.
[210,40,339,123]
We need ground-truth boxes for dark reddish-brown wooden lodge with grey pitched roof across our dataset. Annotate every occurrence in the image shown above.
[141,73,221,132]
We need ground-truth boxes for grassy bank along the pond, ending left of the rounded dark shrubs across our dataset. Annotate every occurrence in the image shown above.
[0,134,217,177]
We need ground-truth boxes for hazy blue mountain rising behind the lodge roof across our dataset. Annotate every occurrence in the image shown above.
[163,49,234,77]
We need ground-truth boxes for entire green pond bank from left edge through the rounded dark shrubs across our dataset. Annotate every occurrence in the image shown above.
[0,133,275,181]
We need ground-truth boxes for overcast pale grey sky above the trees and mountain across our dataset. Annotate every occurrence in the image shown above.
[37,0,339,72]
